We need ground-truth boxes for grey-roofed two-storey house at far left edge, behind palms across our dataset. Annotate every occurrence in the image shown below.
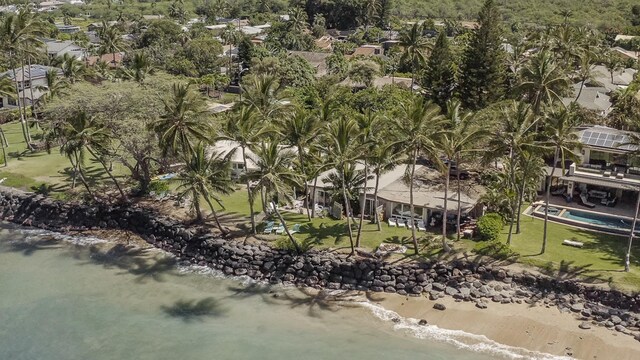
[0,65,62,109]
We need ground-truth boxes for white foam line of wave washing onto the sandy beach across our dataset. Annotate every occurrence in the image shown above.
[359,301,572,360]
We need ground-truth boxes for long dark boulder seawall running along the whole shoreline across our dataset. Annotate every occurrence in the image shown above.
[0,186,640,341]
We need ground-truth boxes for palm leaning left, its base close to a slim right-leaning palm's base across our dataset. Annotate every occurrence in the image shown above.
[321,115,363,255]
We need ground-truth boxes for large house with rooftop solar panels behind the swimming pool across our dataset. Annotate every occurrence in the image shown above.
[551,126,640,216]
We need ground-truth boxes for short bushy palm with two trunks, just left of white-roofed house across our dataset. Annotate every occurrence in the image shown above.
[177,143,233,236]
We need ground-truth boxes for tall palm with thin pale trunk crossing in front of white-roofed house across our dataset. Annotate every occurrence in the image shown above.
[218,106,271,234]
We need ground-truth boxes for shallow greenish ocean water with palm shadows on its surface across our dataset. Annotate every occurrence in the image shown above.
[0,223,564,360]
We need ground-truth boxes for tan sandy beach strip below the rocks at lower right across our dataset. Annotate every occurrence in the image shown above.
[370,294,640,360]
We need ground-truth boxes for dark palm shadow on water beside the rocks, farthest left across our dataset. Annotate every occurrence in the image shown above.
[70,244,182,283]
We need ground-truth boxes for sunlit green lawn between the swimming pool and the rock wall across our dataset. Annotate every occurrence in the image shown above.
[458,210,640,291]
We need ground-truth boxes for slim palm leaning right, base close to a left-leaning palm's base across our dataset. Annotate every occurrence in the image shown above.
[356,109,382,247]
